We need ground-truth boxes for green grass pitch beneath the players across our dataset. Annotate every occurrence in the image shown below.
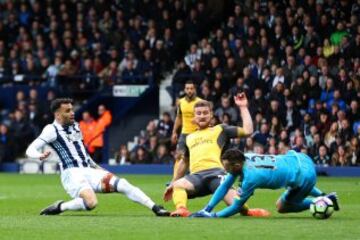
[0,174,360,240]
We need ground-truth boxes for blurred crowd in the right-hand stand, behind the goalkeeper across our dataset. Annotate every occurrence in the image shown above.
[126,0,360,166]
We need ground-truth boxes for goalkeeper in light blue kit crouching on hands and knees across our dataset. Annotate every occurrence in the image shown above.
[192,149,339,217]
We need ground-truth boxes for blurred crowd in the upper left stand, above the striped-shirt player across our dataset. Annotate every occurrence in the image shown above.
[0,0,211,94]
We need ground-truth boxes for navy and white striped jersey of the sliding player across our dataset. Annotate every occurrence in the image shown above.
[37,121,93,170]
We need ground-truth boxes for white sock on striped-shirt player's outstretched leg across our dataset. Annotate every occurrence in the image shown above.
[110,177,155,209]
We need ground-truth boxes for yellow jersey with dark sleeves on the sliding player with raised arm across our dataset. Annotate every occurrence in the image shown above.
[186,124,245,173]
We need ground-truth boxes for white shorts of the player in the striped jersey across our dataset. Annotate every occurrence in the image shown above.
[61,167,109,198]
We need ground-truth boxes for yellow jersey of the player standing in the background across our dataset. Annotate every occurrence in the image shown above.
[178,97,202,134]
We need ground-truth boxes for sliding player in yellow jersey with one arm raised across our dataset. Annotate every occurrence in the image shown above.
[164,93,268,217]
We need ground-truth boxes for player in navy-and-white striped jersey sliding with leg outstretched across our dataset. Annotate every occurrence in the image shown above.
[26,98,169,216]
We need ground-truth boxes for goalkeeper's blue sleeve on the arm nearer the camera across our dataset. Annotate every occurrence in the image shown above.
[216,182,256,218]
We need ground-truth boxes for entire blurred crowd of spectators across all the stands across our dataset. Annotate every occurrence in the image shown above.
[0,0,360,166]
